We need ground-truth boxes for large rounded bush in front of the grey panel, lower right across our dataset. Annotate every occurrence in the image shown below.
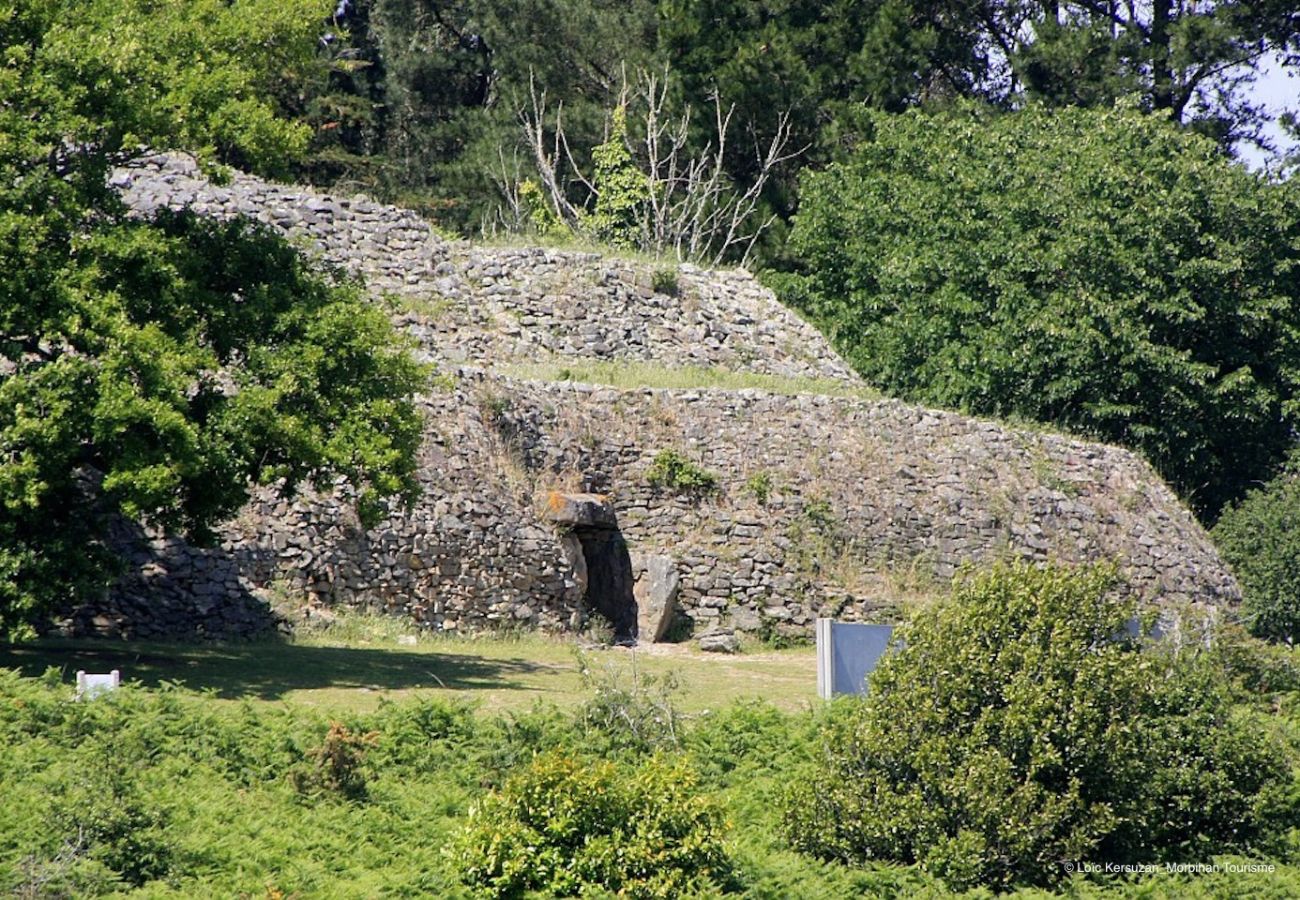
[788,564,1296,888]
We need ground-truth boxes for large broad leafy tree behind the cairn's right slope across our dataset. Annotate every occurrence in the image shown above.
[775,107,1300,516]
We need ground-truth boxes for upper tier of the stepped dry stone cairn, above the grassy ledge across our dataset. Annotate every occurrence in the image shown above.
[111,153,855,381]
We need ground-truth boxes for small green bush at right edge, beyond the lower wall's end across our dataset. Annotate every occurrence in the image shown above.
[1212,458,1300,644]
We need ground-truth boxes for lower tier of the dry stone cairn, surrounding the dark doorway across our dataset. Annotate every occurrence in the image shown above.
[83,369,1238,636]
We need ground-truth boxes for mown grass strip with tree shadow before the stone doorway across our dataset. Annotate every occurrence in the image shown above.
[0,619,816,713]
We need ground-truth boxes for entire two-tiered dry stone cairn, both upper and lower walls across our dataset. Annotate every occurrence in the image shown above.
[72,156,1238,636]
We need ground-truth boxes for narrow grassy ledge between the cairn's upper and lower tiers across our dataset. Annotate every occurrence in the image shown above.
[498,359,881,401]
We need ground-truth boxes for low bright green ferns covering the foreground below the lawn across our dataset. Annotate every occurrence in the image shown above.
[0,652,1300,900]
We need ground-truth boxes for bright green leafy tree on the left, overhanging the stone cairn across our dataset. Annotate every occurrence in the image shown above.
[0,0,424,636]
